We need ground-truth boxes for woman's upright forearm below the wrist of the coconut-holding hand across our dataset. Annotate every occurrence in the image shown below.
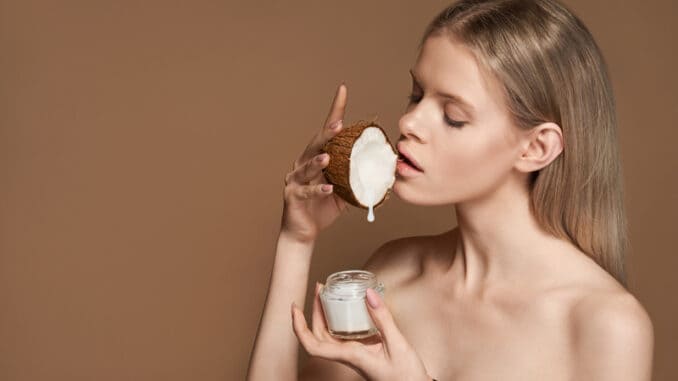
[247,233,315,381]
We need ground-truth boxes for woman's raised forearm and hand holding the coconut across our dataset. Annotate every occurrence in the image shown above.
[247,84,348,381]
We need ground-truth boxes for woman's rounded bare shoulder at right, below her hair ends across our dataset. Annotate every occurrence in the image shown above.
[570,286,654,380]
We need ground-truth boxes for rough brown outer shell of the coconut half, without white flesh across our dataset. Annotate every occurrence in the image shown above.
[322,120,398,210]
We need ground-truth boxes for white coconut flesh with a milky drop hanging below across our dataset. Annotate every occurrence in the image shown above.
[349,127,398,222]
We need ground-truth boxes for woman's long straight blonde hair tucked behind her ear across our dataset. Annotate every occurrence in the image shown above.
[419,0,628,286]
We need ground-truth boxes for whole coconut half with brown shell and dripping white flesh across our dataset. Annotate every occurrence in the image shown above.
[322,120,398,222]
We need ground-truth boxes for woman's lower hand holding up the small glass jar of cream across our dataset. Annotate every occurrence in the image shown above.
[292,284,431,381]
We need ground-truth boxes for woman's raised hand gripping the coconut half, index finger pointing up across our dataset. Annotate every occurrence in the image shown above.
[280,83,348,242]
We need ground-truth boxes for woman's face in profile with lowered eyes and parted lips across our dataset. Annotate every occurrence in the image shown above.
[393,36,525,205]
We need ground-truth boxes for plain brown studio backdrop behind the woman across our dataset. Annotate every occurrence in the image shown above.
[0,0,678,380]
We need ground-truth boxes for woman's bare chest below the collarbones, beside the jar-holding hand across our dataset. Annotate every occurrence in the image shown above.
[393,284,572,380]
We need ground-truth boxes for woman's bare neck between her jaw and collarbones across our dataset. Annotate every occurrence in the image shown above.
[449,174,568,295]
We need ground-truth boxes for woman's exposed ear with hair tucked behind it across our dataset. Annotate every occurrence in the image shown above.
[515,122,563,173]
